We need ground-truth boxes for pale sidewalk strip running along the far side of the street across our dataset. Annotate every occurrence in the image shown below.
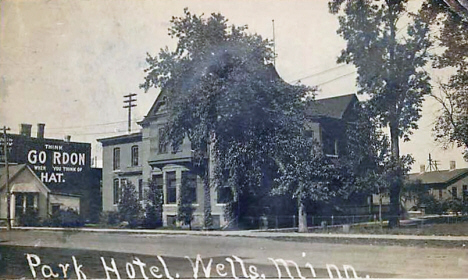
[2,227,468,242]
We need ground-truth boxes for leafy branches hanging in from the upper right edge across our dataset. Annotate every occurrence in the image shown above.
[421,0,468,160]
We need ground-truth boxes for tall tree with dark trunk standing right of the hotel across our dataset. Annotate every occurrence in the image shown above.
[329,0,431,226]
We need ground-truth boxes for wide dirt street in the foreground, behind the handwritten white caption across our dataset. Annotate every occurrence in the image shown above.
[0,231,468,278]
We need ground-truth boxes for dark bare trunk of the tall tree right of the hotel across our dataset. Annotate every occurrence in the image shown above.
[388,123,403,228]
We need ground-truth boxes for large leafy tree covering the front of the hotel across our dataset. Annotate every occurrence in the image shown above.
[142,9,310,230]
